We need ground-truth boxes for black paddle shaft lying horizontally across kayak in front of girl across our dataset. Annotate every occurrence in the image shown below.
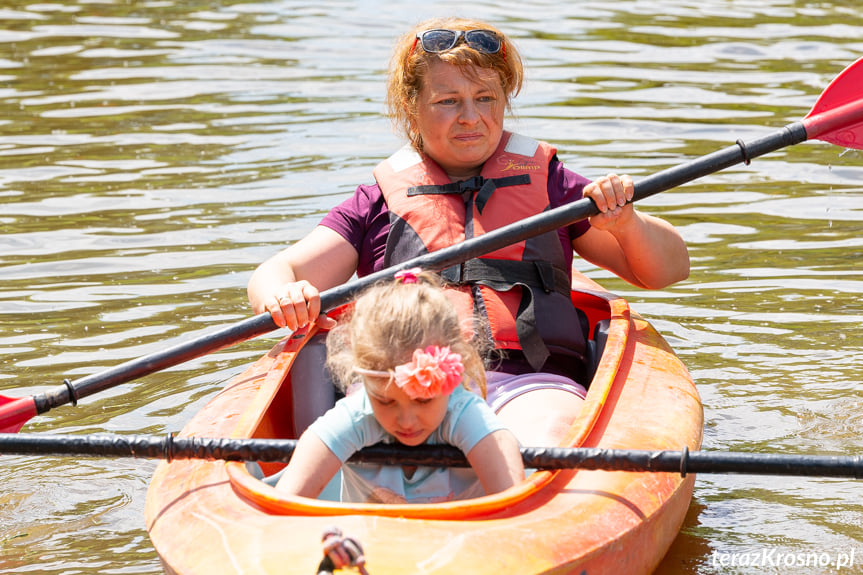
[0,434,863,479]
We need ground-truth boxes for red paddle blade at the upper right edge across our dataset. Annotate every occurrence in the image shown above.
[803,58,863,150]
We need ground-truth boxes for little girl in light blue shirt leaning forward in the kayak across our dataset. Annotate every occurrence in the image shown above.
[276,269,524,503]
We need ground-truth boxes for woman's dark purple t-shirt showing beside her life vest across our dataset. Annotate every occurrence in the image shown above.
[320,159,590,277]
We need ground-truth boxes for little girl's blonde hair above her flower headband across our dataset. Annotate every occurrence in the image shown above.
[327,272,485,397]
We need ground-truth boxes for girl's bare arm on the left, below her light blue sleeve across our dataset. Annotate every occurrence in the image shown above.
[276,431,342,497]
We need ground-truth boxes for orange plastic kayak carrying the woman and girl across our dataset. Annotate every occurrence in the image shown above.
[145,272,703,575]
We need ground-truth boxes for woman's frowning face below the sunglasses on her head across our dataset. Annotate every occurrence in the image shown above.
[414,60,506,180]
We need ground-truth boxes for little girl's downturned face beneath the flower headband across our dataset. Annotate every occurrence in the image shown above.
[365,380,449,445]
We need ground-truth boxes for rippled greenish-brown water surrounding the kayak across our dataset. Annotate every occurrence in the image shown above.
[0,0,863,575]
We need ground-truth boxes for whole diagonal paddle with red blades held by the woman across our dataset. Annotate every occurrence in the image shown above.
[0,58,863,433]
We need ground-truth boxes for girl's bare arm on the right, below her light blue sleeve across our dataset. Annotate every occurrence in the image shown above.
[467,429,524,494]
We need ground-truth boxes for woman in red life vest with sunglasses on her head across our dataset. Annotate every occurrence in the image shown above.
[248,18,689,445]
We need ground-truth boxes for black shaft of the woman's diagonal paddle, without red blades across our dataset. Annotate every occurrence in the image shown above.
[34,122,807,413]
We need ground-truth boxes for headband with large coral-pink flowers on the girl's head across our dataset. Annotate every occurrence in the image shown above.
[354,345,464,399]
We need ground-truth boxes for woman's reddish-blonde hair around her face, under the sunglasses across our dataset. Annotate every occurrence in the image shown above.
[387,18,524,152]
